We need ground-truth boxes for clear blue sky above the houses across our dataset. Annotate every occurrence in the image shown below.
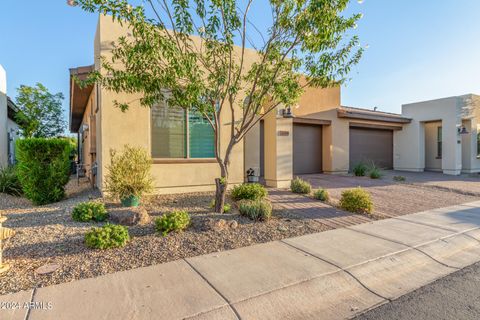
[0,0,480,126]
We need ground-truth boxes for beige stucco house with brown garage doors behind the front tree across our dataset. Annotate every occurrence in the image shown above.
[70,16,411,193]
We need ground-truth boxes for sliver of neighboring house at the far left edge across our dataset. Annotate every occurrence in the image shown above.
[0,65,20,167]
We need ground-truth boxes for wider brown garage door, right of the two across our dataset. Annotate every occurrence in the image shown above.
[350,128,393,169]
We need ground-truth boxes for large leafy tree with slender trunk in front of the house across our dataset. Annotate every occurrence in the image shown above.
[74,0,362,212]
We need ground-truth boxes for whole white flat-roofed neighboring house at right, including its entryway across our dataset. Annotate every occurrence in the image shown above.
[395,94,480,175]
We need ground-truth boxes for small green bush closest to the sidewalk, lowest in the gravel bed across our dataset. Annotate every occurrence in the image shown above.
[85,223,130,249]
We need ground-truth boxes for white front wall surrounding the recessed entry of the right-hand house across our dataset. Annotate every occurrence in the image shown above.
[394,97,462,174]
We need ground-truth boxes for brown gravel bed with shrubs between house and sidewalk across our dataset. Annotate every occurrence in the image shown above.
[0,180,331,294]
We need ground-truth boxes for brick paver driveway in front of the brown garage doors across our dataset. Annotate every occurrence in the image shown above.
[302,174,480,217]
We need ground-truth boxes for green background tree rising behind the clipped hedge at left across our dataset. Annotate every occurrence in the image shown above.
[15,83,65,138]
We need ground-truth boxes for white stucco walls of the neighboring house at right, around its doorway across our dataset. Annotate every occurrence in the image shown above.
[394,96,480,175]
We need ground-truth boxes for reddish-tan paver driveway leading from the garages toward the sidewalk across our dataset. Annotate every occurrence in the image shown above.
[301,171,480,217]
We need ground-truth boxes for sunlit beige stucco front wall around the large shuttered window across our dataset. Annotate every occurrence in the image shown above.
[95,16,256,193]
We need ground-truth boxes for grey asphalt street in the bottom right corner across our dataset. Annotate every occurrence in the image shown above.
[355,263,480,320]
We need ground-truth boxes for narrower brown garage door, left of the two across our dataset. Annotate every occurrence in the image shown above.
[293,124,322,174]
